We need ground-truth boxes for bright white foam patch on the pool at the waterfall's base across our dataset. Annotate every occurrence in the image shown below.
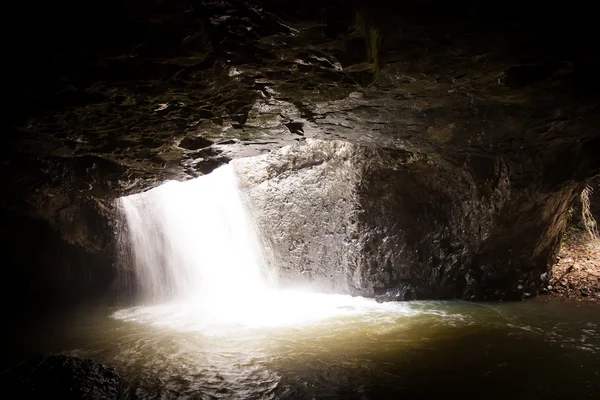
[114,289,420,336]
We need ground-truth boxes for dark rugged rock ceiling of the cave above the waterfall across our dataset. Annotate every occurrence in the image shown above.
[0,0,600,209]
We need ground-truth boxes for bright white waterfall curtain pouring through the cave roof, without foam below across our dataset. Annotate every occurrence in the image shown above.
[118,164,268,303]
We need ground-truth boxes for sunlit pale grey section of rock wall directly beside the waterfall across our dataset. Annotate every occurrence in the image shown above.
[234,140,363,293]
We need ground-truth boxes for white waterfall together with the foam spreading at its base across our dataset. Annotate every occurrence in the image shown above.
[114,164,415,334]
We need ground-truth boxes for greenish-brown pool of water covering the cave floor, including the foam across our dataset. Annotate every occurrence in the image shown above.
[4,295,600,399]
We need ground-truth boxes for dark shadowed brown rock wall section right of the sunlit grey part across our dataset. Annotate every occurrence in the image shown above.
[352,150,510,299]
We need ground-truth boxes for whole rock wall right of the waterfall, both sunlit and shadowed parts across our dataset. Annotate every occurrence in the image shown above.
[234,140,580,300]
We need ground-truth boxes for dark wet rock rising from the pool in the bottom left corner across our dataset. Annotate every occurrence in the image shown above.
[2,356,123,400]
